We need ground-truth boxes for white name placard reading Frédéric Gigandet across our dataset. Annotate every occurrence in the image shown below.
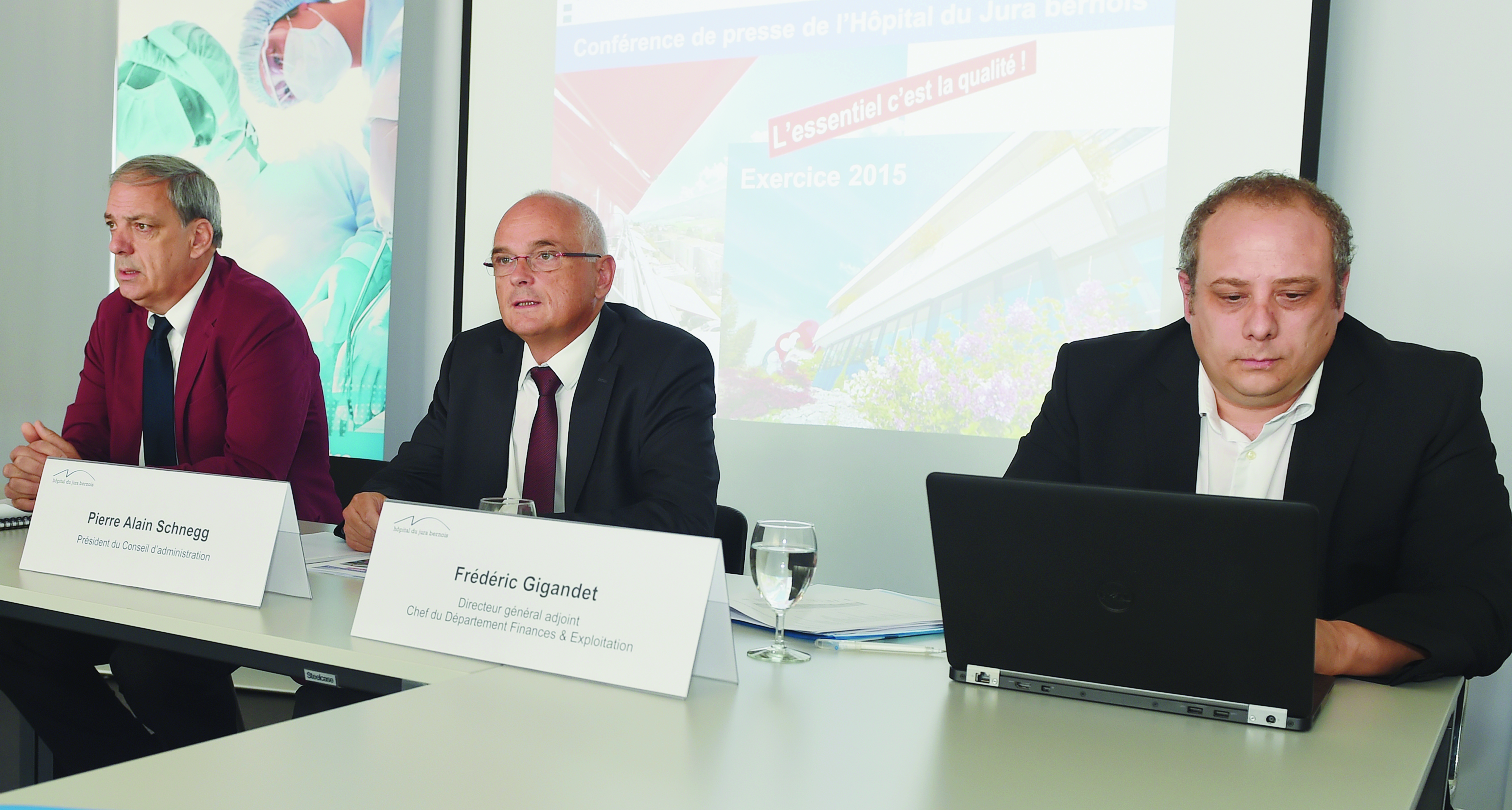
[352,500,736,697]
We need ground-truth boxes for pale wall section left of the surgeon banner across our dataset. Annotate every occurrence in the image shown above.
[0,0,115,435]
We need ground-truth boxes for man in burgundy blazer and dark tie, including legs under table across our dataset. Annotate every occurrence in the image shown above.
[0,156,340,775]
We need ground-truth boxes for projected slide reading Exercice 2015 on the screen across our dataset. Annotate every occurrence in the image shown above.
[552,0,1176,437]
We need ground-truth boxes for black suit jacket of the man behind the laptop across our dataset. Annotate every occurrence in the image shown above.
[1007,316,1512,680]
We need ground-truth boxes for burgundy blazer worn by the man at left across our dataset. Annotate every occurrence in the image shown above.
[62,254,342,523]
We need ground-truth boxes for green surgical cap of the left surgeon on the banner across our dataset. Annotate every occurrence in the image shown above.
[116,21,256,159]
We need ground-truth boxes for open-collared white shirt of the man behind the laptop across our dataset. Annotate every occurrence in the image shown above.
[1198,363,1323,500]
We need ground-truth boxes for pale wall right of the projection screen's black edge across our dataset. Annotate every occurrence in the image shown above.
[1318,0,1512,810]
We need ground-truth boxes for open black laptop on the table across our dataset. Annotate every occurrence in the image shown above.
[925,473,1334,730]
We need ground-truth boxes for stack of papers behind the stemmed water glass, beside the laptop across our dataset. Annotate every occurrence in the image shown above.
[729,574,945,639]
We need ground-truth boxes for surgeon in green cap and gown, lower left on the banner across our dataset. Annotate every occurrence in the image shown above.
[116,23,392,455]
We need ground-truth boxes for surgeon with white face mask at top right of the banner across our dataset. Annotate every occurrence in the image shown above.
[239,0,404,233]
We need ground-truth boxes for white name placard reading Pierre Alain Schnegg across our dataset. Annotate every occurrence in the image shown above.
[21,458,310,606]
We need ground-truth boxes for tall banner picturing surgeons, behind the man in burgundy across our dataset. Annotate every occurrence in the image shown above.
[112,0,404,458]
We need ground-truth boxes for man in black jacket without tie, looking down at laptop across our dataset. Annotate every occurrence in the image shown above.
[1007,174,1512,682]
